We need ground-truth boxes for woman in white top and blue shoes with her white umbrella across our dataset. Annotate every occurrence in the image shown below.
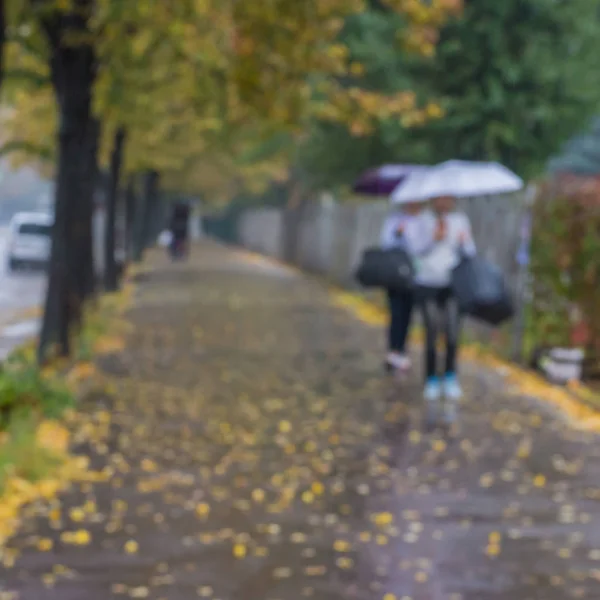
[392,161,523,423]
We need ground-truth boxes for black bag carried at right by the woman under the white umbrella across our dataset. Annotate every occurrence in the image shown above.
[452,256,515,326]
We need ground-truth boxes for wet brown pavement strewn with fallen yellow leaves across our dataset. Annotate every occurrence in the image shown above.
[0,245,600,600]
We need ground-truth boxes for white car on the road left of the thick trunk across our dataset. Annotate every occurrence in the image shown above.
[6,212,54,271]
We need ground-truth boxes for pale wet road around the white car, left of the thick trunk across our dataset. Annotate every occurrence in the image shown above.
[0,228,46,360]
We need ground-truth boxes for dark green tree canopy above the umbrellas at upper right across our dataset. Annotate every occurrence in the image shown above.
[303,0,600,184]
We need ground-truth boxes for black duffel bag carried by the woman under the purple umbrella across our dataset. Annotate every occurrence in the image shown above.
[356,248,415,291]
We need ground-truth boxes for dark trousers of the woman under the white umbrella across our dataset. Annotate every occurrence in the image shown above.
[416,287,461,379]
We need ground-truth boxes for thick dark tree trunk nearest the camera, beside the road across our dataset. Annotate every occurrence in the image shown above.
[38,15,98,363]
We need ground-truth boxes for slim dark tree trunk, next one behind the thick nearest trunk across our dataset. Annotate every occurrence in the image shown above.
[104,127,125,292]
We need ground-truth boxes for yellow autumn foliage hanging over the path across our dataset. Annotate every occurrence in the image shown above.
[3,0,462,197]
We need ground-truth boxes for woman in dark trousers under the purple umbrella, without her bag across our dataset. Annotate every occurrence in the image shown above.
[380,203,423,372]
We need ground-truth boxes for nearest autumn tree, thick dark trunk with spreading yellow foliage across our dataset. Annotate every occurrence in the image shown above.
[1,0,460,360]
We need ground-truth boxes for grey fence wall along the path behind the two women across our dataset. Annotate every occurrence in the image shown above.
[237,197,524,284]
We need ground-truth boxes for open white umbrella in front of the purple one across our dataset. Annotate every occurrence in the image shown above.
[390,160,524,204]
